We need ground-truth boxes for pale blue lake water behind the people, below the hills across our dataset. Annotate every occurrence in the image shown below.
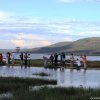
[3,53,100,61]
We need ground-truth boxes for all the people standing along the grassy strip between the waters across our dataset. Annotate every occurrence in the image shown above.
[0,52,87,69]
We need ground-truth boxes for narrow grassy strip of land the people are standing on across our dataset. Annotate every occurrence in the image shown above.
[0,59,100,69]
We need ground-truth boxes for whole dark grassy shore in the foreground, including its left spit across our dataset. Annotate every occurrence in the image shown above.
[0,77,100,100]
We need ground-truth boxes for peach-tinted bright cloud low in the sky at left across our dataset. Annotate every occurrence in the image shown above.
[2,33,51,48]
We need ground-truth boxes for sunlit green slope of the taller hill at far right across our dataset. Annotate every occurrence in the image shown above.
[67,37,100,50]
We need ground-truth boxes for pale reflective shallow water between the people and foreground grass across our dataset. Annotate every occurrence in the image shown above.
[0,66,100,88]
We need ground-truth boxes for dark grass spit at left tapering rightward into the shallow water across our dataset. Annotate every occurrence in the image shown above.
[0,77,57,93]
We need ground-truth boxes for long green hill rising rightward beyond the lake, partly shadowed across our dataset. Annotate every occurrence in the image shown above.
[31,37,100,54]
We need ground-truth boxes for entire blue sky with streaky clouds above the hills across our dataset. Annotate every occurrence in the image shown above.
[0,0,100,49]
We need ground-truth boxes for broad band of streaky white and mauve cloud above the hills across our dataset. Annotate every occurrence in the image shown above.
[0,12,100,48]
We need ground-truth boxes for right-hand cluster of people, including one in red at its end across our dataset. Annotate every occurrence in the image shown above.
[43,52,87,69]
